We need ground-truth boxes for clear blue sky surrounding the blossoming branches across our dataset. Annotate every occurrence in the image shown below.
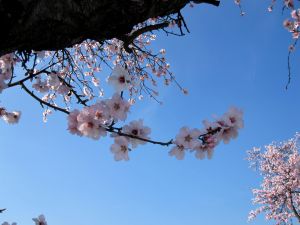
[0,0,300,225]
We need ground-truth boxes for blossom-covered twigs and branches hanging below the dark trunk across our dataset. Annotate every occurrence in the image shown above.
[0,1,243,160]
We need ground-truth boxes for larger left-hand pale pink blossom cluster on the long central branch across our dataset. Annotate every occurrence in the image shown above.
[68,93,155,160]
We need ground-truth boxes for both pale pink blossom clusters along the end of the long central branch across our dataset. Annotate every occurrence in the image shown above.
[68,93,244,161]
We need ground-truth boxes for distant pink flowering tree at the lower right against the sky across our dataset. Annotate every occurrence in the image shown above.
[248,134,300,224]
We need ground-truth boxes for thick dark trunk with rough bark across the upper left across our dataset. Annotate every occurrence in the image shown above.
[0,0,219,56]
